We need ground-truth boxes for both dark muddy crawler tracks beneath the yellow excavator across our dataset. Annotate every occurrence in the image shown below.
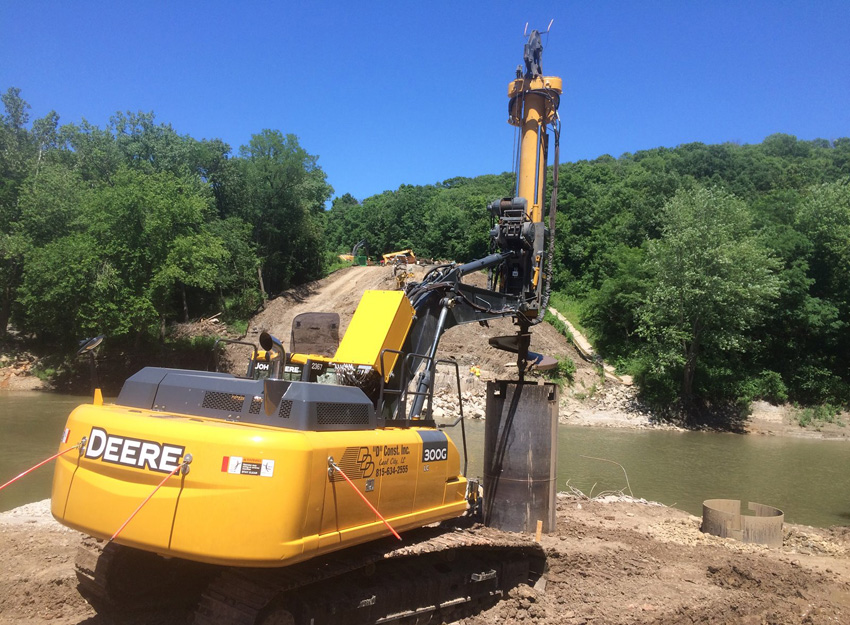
[76,519,546,625]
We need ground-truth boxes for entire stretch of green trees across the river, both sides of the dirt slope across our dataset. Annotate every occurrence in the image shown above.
[0,88,850,412]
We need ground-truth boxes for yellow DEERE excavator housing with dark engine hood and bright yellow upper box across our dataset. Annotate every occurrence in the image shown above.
[52,291,467,567]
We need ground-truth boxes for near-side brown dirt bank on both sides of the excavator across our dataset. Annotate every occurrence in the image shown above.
[0,494,850,625]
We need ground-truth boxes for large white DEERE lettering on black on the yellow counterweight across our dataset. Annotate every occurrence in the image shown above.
[85,427,186,473]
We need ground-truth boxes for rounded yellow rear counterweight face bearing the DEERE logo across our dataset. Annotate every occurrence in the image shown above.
[52,406,312,563]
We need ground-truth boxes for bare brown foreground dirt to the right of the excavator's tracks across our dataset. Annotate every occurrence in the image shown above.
[462,497,850,625]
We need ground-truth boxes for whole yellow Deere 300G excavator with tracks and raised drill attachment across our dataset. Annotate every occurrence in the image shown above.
[52,26,561,625]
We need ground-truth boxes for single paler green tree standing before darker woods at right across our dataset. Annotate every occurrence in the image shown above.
[637,187,778,409]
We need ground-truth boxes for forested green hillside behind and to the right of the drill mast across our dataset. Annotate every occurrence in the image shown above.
[326,134,850,415]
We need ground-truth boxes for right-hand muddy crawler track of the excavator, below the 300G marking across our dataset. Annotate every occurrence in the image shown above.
[194,526,545,625]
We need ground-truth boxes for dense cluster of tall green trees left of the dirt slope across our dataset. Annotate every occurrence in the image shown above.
[0,88,333,347]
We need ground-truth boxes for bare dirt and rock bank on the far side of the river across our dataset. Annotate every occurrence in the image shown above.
[0,265,850,439]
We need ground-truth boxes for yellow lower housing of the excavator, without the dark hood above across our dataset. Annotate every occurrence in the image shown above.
[52,405,467,567]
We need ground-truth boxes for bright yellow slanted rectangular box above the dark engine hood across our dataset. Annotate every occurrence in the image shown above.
[333,291,414,381]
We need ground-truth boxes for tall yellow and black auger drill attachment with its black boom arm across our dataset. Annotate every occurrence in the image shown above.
[406,24,562,410]
